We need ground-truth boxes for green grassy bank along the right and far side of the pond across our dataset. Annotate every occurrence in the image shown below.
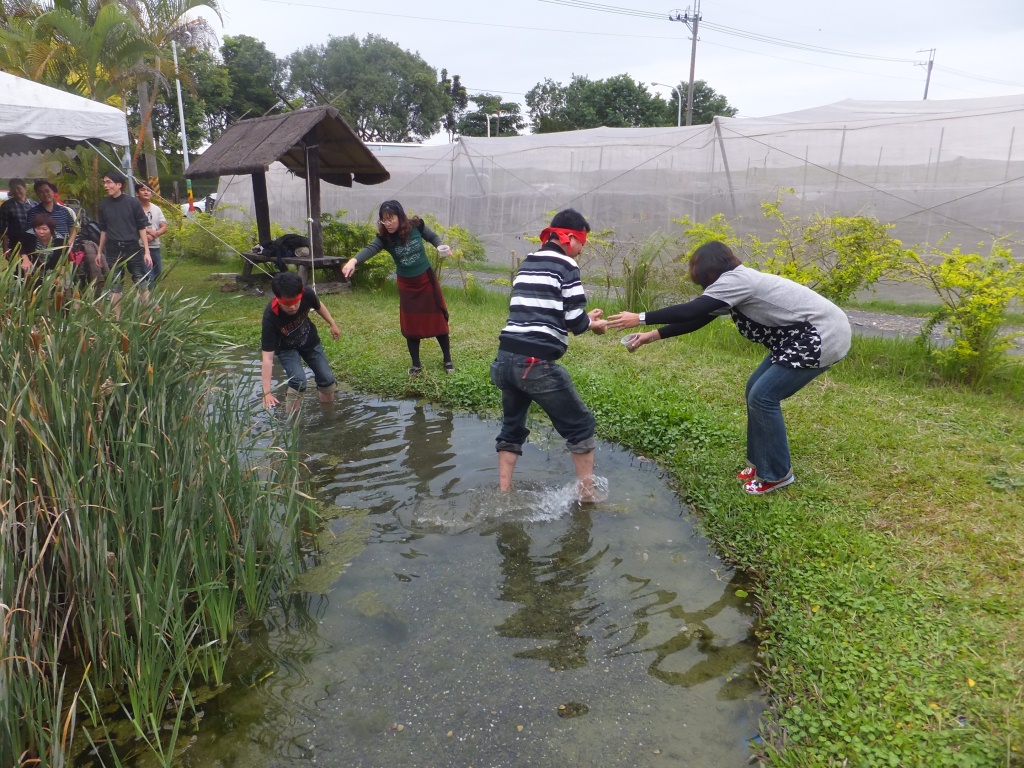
[169,267,1024,766]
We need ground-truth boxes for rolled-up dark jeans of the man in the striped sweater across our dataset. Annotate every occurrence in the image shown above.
[490,350,596,456]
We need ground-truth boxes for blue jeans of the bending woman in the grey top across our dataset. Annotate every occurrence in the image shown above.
[746,355,828,482]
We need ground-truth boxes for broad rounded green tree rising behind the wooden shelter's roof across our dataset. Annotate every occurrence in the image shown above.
[288,35,454,141]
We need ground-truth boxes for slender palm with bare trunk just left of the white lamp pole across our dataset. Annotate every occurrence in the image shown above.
[120,0,223,185]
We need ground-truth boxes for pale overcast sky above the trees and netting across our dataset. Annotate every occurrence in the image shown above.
[203,0,1024,132]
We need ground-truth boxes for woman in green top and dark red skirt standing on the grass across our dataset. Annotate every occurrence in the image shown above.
[341,200,455,376]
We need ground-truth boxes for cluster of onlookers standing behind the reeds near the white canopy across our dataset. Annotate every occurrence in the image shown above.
[0,169,167,315]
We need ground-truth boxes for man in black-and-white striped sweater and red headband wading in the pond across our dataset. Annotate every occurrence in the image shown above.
[490,208,607,503]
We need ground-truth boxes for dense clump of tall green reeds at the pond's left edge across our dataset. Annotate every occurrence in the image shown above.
[0,267,302,766]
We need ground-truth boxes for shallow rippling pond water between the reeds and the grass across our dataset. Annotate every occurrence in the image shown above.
[181,395,762,768]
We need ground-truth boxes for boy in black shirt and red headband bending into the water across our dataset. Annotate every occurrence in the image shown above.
[260,272,341,413]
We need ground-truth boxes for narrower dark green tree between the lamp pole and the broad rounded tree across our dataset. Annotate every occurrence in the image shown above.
[221,35,289,123]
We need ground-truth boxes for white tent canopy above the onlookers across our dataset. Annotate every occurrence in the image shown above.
[0,72,128,156]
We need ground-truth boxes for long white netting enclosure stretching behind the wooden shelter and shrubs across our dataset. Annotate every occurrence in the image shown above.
[211,95,1024,263]
